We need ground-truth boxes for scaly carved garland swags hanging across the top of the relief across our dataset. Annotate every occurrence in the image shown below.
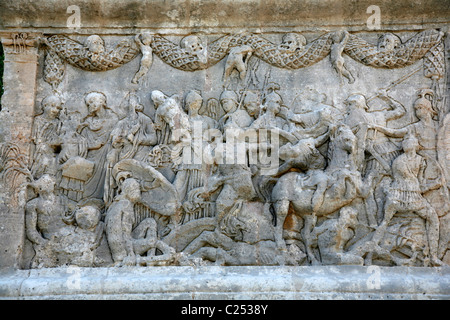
[47,29,444,78]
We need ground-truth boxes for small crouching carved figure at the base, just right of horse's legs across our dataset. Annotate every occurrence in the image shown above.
[310,207,364,265]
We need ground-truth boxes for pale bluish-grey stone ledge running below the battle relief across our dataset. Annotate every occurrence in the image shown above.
[0,266,450,300]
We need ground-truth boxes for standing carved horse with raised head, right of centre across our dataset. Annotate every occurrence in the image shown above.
[272,125,368,260]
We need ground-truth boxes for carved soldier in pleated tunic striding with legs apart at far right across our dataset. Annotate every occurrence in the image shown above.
[372,134,442,266]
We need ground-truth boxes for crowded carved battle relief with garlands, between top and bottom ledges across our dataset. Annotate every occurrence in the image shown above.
[0,30,450,268]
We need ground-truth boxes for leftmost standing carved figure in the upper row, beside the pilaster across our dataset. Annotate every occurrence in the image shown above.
[31,95,62,179]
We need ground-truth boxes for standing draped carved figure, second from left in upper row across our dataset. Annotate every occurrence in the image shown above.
[77,91,118,199]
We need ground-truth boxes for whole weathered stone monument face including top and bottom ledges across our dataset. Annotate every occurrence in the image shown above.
[0,0,450,298]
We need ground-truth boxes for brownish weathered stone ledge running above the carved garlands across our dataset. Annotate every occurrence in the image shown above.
[0,0,449,33]
